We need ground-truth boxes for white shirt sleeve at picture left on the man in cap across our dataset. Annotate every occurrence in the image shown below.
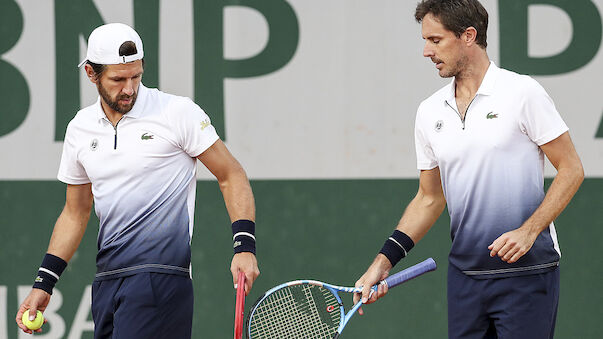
[57,123,90,185]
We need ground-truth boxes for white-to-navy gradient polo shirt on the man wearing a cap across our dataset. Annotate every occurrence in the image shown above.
[58,84,218,280]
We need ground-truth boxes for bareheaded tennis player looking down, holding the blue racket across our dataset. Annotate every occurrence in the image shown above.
[355,0,584,339]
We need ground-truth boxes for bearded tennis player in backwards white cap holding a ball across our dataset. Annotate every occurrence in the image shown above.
[16,23,259,338]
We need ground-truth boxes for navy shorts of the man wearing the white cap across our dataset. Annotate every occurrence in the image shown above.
[92,273,193,339]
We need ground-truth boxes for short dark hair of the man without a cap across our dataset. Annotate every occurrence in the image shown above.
[415,0,488,48]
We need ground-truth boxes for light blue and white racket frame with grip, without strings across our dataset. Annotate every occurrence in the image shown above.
[245,258,437,339]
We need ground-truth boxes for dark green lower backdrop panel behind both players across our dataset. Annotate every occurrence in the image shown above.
[0,179,603,339]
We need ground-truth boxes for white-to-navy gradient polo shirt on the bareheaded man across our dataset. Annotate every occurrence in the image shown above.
[415,62,568,278]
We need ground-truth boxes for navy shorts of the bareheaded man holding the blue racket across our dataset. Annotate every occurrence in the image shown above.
[448,265,559,339]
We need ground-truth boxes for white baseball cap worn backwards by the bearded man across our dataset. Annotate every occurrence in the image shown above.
[77,23,144,67]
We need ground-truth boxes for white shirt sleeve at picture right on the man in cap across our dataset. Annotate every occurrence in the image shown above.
[170,97,219,157]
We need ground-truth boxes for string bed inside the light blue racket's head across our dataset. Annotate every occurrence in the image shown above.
[249,284,341,339]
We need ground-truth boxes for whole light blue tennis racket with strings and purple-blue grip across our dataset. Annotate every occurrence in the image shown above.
[246,258,436,339]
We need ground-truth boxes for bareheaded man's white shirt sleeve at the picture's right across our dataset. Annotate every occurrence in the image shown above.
[520,78,568,146]
